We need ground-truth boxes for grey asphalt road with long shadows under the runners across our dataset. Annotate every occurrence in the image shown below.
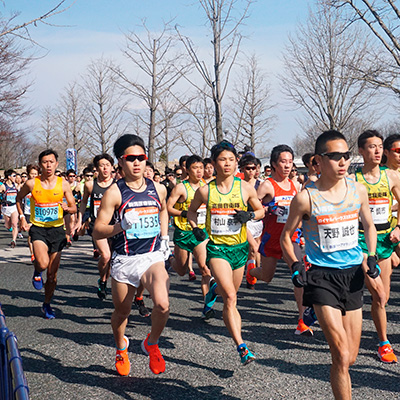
[0,225,400,400]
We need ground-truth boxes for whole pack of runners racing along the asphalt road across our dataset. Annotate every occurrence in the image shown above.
[3,130,400,399]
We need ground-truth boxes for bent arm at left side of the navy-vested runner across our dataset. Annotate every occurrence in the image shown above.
[92,183,122,240]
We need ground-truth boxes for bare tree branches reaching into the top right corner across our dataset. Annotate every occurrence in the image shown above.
[327,0,400,95]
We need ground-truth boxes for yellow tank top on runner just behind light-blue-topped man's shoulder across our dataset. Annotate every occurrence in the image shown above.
[355,169,396,233]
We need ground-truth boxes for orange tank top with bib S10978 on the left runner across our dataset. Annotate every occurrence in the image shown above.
[30,177,64,228]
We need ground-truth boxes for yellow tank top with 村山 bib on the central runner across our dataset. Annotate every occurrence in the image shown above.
[206,177,247,246]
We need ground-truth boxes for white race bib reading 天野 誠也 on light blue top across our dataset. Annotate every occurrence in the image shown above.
[317,211,358,253]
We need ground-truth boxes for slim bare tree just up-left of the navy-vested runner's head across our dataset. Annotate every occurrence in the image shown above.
[83,58,129,155]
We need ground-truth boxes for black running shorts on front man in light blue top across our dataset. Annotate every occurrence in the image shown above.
[303,265,364,315]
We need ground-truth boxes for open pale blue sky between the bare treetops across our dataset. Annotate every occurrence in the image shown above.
[6,0,313,156]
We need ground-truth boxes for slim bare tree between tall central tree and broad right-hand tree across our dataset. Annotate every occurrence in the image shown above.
[230,54,276,151]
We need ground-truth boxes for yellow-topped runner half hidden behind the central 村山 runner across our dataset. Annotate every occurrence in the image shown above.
[167,155,211,304]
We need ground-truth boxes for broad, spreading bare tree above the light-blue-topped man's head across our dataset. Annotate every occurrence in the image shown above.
[280,1,377,136]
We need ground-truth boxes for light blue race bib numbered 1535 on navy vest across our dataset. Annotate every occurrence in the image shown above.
[125,207,160,239]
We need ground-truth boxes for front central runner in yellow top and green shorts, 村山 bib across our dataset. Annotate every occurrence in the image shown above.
[188,140,264,365]
